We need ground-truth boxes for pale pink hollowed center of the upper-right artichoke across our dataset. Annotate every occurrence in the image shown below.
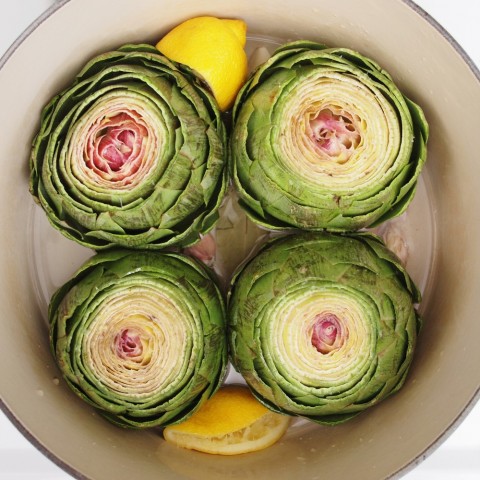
[307,107,361,161]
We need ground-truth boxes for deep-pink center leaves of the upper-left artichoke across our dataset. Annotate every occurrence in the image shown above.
[86,111,148,180]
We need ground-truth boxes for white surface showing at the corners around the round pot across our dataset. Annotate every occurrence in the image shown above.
[0,0,480,480]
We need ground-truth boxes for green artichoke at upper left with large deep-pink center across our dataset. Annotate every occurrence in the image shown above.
[30,44,227,249]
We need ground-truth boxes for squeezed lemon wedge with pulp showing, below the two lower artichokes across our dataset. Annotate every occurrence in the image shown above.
[163,385,290,455]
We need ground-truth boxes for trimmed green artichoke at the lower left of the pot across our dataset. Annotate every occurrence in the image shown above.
[49,249,227,428]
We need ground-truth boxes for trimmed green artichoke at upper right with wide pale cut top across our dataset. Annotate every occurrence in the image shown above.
[230,41,428,232]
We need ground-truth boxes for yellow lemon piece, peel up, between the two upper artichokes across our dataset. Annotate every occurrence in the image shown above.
[156,16,248,111]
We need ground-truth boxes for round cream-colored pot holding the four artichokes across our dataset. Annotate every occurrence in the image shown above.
[0,0,480,480]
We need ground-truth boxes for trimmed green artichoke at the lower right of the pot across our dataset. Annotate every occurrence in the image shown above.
[228,233,420,424]
